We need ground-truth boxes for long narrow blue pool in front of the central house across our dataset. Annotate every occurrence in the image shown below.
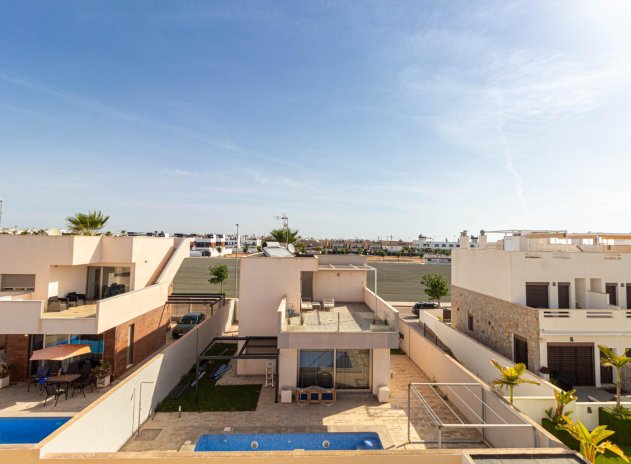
[195,432,383,451]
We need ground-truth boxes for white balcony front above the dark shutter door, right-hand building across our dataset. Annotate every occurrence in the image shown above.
[538,309,631,336]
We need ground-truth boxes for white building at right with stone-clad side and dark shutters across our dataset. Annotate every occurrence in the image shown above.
[451,231,631,386]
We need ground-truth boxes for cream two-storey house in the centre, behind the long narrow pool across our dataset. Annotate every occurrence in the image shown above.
[237,247,399,394]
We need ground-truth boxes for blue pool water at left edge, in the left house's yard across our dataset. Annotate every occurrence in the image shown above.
[0,417,70,445]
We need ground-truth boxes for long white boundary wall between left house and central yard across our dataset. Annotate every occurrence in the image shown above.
[39,300,235,456]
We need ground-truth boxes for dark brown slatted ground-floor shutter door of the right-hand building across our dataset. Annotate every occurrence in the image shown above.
[548,345,594,386]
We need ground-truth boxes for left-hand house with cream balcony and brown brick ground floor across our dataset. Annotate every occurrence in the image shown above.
[0,235,190,380]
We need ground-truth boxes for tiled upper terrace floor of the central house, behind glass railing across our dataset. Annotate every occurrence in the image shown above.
[286,303,390,332]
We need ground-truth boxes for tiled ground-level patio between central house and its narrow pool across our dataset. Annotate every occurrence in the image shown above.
[122,356,479,451]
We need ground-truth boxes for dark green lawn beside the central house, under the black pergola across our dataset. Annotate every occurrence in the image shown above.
[157,343,262,412]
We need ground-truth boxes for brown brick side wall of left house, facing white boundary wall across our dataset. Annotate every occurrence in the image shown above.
[104,305,171,376]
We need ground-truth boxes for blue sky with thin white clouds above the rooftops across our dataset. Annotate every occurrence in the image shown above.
[0,0,631,240]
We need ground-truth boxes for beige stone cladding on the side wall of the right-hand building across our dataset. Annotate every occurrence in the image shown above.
[451,285,541,373]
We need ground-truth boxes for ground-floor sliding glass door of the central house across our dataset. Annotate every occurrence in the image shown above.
[298,350,370,390]
